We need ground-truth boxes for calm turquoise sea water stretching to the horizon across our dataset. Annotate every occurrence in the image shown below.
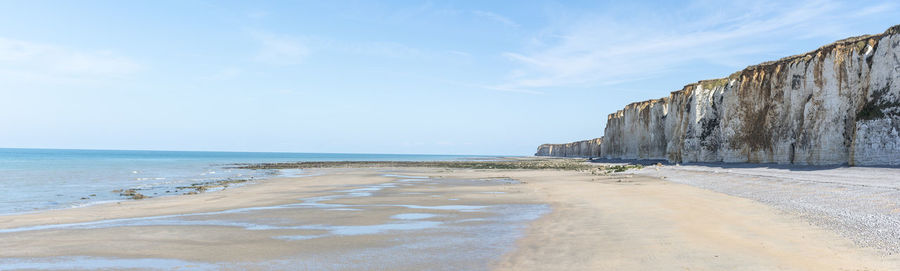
[0,148,485,214]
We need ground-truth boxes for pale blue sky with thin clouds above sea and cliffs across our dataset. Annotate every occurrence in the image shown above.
[0,0,900,155]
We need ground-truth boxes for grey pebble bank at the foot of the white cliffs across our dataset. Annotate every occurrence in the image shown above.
[640,164,900,254]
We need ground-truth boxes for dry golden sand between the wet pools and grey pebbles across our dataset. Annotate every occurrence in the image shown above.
[488,172,900,270]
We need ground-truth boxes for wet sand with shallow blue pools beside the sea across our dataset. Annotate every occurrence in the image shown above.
[0,169,550,270]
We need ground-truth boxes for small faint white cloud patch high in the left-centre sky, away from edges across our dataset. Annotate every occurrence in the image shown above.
[253,32,310,65]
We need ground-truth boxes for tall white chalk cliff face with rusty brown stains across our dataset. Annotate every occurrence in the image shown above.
[537,26,900,165]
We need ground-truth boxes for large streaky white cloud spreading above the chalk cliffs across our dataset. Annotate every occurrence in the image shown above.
[493,1,896,89]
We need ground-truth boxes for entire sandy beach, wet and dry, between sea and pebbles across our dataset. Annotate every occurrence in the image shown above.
[0,163,900,270]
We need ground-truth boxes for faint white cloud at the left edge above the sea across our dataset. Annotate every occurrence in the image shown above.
[0,38,143,83]
